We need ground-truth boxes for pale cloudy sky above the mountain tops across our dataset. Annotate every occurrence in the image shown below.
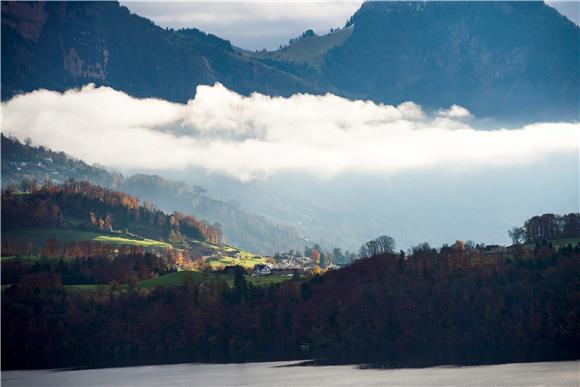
[121,0,580,50]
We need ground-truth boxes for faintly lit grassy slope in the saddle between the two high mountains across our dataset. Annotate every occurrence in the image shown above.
[251,28,352,69]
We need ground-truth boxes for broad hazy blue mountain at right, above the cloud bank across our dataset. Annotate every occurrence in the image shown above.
[323,1,580,119]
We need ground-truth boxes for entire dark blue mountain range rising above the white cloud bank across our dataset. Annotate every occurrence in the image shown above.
[2,1,580,122]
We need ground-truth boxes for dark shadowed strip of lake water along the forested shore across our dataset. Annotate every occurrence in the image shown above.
[2,346,580,370]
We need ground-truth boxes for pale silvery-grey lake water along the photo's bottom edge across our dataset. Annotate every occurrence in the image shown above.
[2,361,580,387]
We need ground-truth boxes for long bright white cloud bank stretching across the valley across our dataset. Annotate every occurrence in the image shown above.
[2,84,580,180]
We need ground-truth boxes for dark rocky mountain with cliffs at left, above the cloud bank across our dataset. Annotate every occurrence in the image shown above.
[2,2,313,102]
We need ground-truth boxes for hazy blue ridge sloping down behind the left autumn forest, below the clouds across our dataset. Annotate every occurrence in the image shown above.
[1,135,305,254]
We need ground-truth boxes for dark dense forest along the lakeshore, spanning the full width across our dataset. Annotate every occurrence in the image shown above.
[2,236,580,368]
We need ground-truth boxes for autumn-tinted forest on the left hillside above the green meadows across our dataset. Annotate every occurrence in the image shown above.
[2,179,221,249]
